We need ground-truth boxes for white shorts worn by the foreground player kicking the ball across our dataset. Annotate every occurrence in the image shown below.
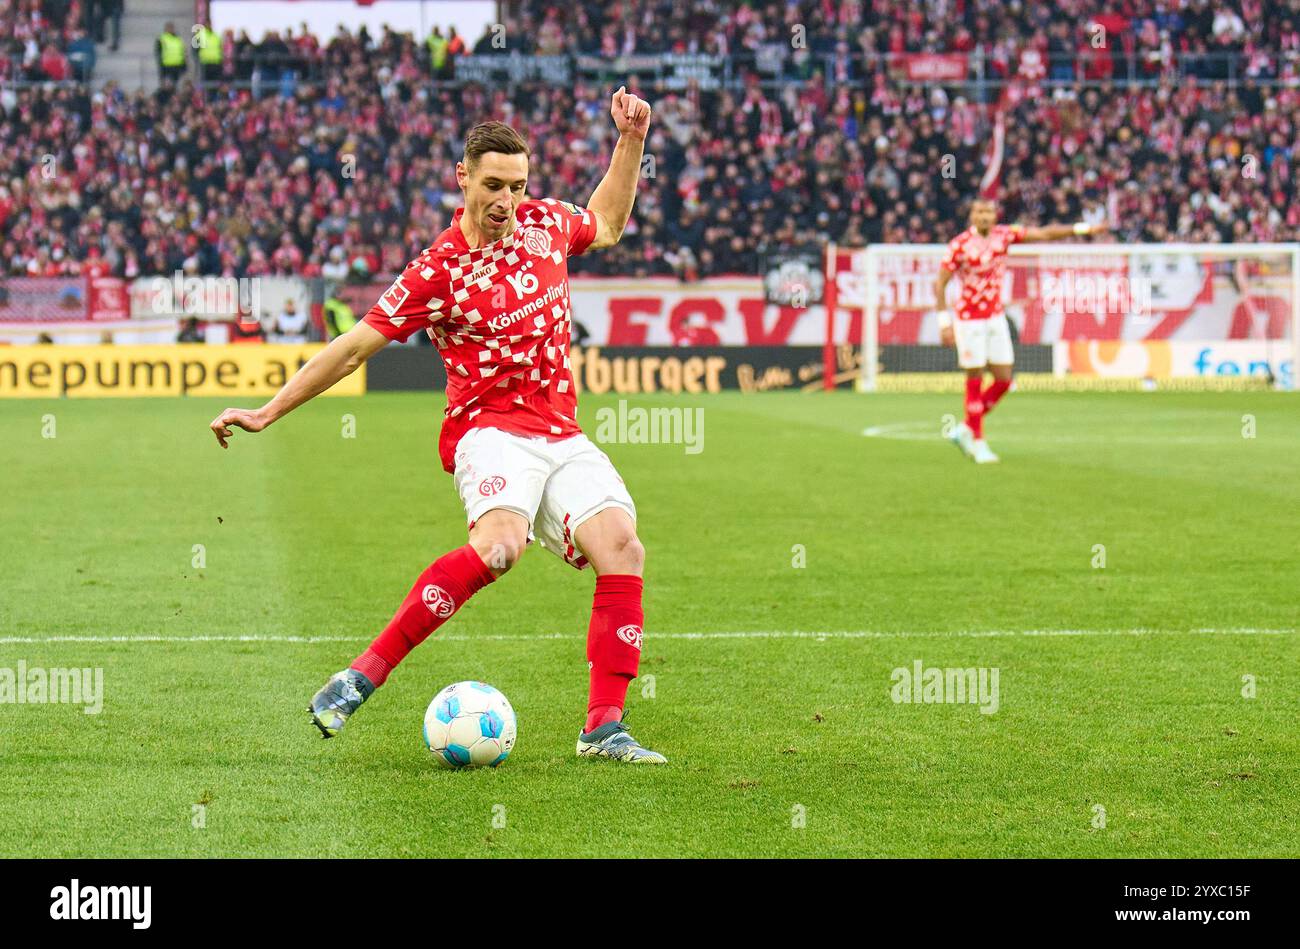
[454,428,637,569]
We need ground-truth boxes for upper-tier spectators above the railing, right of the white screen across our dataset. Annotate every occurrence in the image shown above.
[491,0,1300,79]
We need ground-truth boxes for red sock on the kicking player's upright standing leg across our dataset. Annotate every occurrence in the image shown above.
[584,573,645,732]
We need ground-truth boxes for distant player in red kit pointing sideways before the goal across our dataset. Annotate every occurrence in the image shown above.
[935,200,1106,464]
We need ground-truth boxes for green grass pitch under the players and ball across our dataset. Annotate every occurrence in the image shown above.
[0,391,1300,857]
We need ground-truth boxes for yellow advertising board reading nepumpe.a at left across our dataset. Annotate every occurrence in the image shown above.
[0,343,365,399]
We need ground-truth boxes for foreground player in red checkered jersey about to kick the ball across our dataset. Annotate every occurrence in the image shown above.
[212,88,667,764]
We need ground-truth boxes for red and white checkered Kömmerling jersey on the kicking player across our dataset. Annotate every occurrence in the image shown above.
[365,198,595,472]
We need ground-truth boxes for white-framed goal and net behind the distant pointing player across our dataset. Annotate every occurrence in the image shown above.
[826,243,1300,391]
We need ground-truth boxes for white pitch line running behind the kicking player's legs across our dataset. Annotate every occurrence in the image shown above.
[0,627,1297,645]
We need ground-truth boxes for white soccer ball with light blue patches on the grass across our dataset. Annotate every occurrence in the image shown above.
[424,683,515,768]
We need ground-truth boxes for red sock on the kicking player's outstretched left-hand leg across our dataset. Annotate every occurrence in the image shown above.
[351,543,493,688]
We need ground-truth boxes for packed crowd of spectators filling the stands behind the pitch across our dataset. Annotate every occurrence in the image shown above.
[0,0,1300,281]
